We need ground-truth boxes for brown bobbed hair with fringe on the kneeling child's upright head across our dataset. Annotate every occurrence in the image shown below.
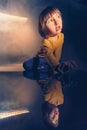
[38,6,62,38]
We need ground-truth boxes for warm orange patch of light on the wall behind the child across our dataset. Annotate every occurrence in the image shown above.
[0,13,38,64]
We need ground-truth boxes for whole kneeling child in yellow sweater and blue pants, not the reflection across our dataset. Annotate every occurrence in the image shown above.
[23,7,77,72]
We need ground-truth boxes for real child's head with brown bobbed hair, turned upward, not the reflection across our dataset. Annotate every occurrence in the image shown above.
[38,7,62,38]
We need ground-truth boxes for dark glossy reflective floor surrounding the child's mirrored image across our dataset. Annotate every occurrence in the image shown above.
[0,70,87,130]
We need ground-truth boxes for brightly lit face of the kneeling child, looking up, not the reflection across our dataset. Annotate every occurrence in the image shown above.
[46,13,62,37]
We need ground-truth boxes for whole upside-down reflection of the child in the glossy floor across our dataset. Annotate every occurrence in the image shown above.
[41,77,64,127]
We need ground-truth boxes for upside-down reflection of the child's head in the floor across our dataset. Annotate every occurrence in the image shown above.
[42,102,59,127]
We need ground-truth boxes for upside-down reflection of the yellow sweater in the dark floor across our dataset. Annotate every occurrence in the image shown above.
[44,79,64,106]
